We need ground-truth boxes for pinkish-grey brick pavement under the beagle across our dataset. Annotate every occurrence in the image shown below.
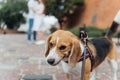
[0,34,120,80]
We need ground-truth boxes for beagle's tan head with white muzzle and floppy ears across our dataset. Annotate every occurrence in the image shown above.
[45,30,81,67]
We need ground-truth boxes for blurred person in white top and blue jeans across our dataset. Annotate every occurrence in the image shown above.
[27,0,37,43]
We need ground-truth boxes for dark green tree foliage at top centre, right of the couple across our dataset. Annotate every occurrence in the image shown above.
[46,0,84,18]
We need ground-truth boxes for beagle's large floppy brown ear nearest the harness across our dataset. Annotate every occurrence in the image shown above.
[69,39,81,67]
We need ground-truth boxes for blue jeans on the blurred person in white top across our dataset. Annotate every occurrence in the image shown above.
[28,18,37,41]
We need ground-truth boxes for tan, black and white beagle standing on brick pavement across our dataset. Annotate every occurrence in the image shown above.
[45,11,120,80]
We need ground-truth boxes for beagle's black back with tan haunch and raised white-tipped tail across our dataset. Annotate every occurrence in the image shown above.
[90,11,120,67]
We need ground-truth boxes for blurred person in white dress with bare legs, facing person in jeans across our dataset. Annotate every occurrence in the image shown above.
[32,0,45,44]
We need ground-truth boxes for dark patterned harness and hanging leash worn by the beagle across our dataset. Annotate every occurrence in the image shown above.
[80,31,94,80]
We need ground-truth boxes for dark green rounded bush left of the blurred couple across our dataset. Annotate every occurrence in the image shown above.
[0,0,27,29]
